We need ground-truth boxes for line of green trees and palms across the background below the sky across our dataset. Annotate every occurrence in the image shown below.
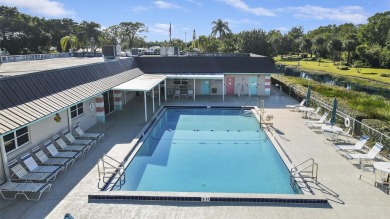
[0,6,390,68]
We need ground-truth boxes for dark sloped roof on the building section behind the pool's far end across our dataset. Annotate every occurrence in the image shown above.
[135,56,280,74]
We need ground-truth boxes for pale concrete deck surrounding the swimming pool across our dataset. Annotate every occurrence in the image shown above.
[0,87,390,219]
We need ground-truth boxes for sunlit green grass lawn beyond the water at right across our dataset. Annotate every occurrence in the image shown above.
[275,57,390,85]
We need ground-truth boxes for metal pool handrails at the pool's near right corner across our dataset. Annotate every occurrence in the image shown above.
[290,158,318,190]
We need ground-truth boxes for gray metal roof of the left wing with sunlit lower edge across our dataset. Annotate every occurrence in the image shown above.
[0,58,143,135]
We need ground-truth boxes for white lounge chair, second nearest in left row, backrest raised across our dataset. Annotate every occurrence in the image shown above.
[8,159,55,182]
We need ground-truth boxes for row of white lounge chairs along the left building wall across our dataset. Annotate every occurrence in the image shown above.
[0,126,104,200]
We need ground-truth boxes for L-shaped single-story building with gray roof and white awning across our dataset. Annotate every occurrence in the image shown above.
[0,54,279,181]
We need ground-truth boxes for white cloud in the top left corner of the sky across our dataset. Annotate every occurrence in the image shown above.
[0,0,76,17]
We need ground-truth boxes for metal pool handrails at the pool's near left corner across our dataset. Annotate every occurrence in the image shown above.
[98,154,126,189]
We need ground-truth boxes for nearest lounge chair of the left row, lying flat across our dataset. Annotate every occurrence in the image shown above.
[0,182,51,201]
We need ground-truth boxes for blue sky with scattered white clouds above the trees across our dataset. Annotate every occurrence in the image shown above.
[0,0,390,42]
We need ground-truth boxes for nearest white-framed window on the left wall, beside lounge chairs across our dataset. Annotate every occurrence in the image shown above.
[3,127,30,153]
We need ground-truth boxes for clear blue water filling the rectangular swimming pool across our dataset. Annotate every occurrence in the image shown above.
[115,109,296,194]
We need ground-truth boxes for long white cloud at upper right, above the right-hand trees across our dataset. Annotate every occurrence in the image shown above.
[284,5,368,24]
